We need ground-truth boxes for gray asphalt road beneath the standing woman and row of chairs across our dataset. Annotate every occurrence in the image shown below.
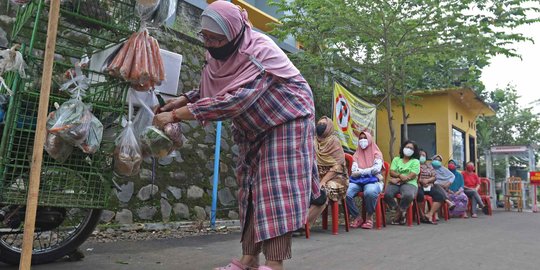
[0,211,540,270]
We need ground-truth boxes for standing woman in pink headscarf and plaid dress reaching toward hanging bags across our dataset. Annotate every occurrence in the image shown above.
[154,1,320,270]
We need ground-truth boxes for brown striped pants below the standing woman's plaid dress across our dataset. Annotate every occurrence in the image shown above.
[242,195,292,261]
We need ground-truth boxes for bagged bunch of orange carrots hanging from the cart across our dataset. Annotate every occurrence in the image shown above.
[107,29,165,91]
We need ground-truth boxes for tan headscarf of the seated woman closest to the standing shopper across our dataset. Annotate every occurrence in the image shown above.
[315,116,345,166]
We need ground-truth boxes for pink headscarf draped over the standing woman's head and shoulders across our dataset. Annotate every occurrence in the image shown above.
[199,1,300,98]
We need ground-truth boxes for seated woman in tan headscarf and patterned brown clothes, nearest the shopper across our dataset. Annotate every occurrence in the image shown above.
[308,116,349,223]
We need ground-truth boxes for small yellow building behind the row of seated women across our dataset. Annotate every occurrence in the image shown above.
[377,88,495,168]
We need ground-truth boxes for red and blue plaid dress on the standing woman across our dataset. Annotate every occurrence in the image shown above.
[186,75,320,242]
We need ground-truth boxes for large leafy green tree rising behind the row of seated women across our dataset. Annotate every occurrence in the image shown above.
[274,0,539,156]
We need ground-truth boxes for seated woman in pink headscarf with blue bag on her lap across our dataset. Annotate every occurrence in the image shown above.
[347,131,384,229]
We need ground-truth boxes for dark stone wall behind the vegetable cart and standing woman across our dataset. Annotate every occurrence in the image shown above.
[0,1,238,223]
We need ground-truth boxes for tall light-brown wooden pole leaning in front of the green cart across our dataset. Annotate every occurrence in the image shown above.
[19,0,60,270]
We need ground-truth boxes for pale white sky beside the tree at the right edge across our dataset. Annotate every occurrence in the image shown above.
[481,23,540,112]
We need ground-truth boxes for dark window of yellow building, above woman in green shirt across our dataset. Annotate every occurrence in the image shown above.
[401,123,437,158]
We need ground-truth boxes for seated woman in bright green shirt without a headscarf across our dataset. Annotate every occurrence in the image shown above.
[384,141,420,225]
